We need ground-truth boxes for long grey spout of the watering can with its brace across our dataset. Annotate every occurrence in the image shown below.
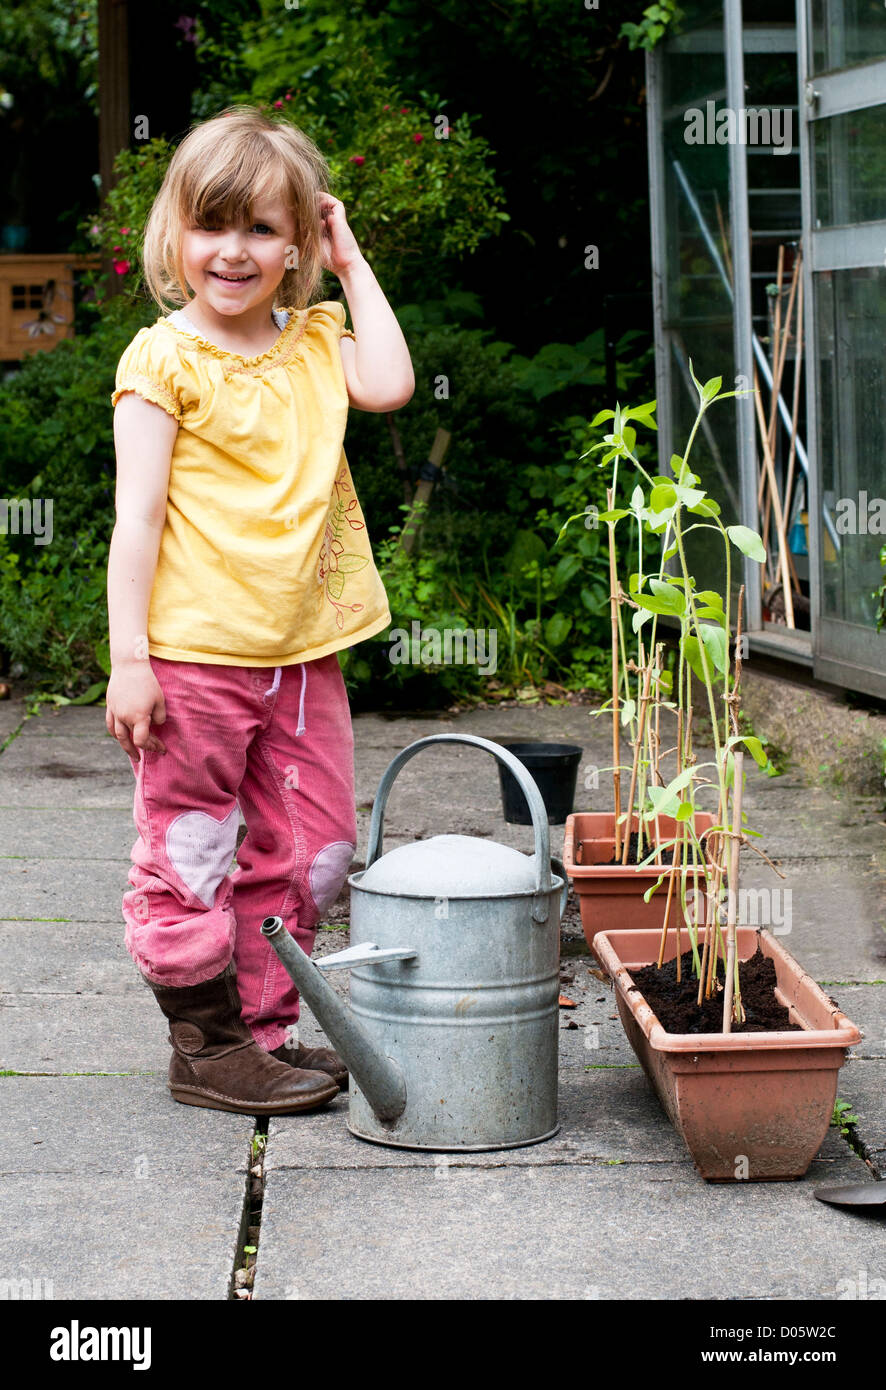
[261,917,406,1125]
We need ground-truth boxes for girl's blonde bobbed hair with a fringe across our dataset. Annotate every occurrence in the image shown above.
[142,106,330,311]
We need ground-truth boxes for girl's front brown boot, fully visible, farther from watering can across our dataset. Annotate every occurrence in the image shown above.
[142,962,338,1115]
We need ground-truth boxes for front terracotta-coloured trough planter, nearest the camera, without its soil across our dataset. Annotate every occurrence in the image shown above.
[597,927,861,1183]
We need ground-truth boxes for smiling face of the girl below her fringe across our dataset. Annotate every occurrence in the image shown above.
[182,197,298,317]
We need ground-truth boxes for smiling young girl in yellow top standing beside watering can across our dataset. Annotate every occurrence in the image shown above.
[106,107,414,1115]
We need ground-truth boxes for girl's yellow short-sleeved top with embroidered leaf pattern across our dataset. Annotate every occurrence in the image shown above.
[111,300,391,666]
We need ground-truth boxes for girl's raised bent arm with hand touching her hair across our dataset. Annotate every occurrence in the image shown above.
[320,193,416,410]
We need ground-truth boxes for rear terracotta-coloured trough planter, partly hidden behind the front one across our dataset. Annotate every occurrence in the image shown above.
[563,810,715,959]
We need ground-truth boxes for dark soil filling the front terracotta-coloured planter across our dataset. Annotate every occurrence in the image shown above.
[631,947,803,1033]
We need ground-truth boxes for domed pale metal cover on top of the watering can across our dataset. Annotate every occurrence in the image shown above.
[359,835,535,898]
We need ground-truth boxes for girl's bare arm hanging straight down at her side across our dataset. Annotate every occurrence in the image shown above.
[104,392,178,758]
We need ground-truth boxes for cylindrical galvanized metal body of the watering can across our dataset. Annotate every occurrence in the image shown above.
[349,874,559,1151]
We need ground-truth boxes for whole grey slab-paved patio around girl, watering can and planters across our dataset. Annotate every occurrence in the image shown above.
[0,702,886,1300]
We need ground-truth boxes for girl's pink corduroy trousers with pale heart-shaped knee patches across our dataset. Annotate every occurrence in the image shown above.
[122,653,356,1051]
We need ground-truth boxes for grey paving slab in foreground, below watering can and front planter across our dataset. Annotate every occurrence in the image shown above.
[255,1145,886,1301]
